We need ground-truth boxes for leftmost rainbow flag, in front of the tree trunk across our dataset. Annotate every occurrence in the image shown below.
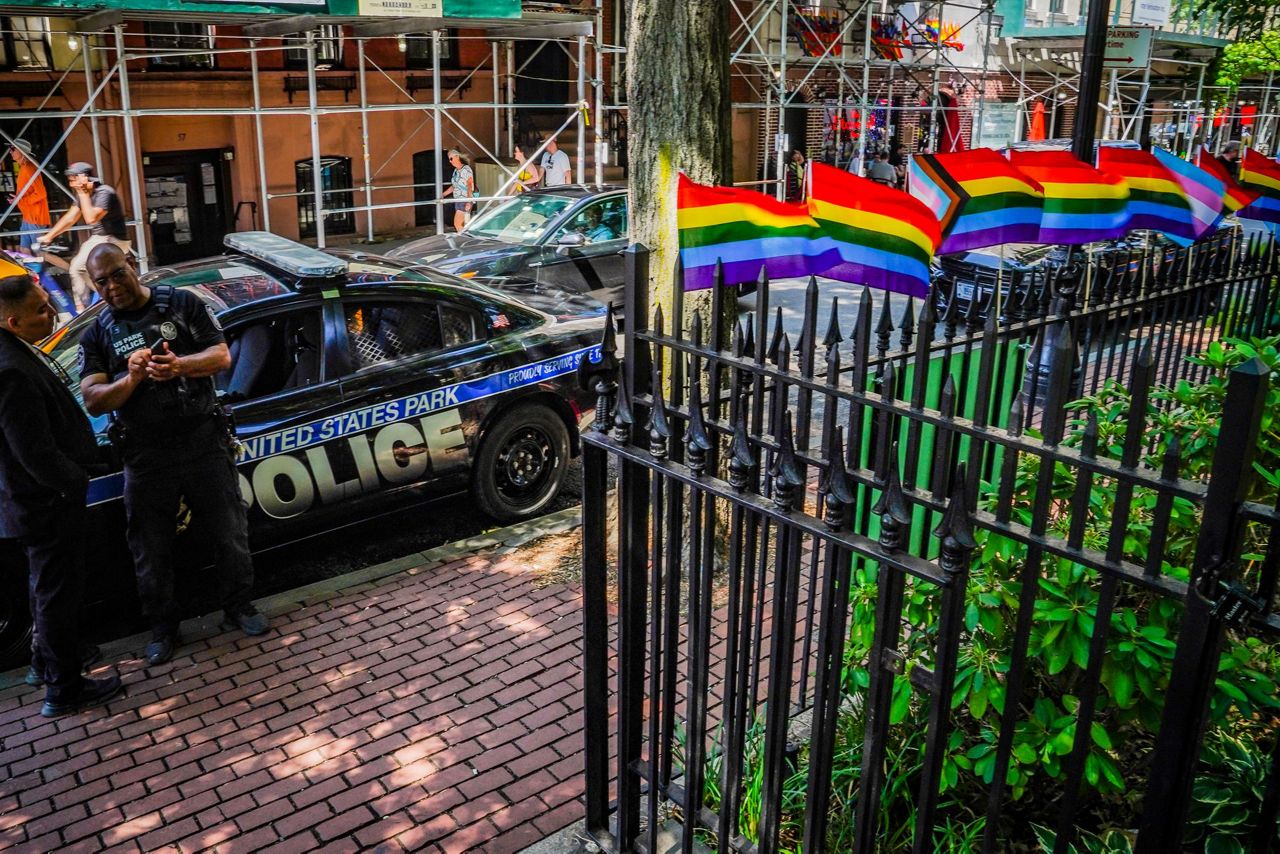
[676,174,840,291]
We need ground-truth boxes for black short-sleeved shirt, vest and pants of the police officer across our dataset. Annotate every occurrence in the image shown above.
[81,286,253,638]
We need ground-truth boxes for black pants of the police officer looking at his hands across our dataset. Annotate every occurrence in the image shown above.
[124,421,253,634]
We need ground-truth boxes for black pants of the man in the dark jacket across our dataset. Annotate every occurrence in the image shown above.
[22,501,84,699]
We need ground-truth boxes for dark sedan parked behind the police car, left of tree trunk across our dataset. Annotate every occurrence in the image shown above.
[389,184,628,306]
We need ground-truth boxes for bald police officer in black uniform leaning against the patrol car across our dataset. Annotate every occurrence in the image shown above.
[81,243,268,665]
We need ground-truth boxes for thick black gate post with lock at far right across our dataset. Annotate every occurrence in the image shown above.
[1137,359,1268,854]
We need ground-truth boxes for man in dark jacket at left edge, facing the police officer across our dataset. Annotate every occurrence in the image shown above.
[0,275,120,717]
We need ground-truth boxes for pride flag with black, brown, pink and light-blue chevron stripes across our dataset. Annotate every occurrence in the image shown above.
[910,149,1044,254]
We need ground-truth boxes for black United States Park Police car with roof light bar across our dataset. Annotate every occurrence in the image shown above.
[0,232,605,663]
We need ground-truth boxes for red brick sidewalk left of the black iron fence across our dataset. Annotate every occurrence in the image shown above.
[0,511,596,854]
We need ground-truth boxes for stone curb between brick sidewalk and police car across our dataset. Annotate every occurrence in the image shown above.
[0,506,582,690]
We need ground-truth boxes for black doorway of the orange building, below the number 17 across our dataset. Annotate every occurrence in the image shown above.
[143,149,232,264]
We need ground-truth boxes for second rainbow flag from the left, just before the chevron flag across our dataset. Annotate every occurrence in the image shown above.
[809,163,942,297]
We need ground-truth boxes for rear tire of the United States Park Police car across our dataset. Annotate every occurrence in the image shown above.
[471,403,570,522]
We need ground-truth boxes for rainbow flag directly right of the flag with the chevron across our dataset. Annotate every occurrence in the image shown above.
[1009,151,1129,243]
